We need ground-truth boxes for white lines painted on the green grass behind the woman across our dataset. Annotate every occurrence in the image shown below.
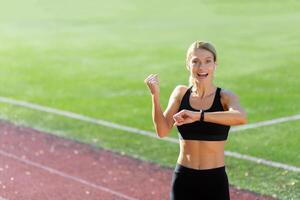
[0,96,300,172]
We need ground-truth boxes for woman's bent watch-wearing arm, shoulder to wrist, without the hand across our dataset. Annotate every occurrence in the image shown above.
[204,90,247,126]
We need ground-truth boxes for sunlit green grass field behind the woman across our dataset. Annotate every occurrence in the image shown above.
[0,0,300,199]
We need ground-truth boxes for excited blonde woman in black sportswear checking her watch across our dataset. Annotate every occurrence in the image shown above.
[145,41,247,200]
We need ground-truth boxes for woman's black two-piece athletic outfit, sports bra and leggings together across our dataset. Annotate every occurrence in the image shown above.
[170,87,230,200]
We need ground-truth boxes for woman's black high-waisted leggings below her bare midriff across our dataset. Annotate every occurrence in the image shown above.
[170,163,230,200]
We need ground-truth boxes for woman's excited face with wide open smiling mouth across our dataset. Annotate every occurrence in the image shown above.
[188,49,216,83]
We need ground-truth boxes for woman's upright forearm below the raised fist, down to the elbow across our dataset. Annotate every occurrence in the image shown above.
[152,95,170,137]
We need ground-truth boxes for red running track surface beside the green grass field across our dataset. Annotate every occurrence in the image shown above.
[0,122,272,200]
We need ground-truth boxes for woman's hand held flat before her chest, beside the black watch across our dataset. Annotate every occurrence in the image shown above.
[173,110,201,126]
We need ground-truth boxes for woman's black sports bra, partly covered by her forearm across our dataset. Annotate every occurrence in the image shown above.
[177,87,230,141]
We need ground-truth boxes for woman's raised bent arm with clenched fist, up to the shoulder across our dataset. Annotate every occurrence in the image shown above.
[145,74,185,138]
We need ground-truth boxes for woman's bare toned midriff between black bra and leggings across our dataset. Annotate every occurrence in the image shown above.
[177,140,225,169]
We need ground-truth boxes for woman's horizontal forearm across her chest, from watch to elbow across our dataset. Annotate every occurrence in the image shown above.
[204,110,247,126]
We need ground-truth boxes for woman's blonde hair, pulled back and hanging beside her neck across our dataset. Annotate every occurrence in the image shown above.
[186,41,217,93]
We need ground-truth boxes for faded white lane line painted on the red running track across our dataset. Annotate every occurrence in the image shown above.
[0,150,138,200]
